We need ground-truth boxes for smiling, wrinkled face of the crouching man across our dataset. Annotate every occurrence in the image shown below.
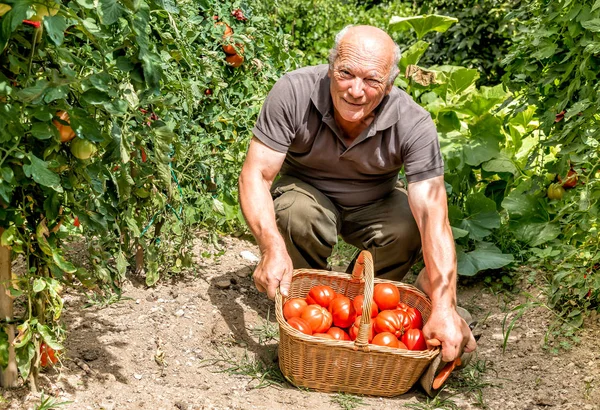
[329,43,392,122]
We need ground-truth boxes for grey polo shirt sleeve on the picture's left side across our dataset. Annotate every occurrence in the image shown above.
[252,75,297,153]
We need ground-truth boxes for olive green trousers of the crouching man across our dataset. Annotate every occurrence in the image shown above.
[271,176,421,280]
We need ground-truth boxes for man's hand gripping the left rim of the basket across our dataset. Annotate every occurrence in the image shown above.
[253,251,294,299]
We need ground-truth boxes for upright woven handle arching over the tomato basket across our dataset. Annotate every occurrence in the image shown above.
[352,251,375,350]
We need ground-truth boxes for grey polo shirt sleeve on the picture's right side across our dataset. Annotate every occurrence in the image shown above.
[404,113,444,183]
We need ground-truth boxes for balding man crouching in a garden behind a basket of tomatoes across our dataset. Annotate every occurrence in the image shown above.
[239,26,476,361]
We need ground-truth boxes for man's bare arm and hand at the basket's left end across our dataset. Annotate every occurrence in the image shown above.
[239,138,293,299]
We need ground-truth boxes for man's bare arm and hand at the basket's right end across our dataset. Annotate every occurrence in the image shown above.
[408,176,476,361]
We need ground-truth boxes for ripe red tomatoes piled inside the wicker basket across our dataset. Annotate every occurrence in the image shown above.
[283,283,427,350]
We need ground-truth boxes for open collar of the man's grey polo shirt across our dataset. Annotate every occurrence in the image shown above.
[310,64,400,131]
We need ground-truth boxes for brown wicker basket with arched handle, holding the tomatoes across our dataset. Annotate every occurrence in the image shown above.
[275,251,439,397]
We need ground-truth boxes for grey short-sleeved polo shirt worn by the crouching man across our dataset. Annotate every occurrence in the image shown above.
[253,64,444,206]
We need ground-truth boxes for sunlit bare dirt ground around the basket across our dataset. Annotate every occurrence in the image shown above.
[0,237,600,410]
